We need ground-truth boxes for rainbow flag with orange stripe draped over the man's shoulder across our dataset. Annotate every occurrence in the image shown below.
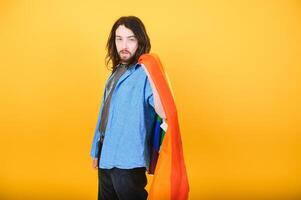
[138,54,189,200]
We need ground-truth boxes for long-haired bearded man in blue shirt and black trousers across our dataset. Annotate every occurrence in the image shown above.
[90,16,155,200]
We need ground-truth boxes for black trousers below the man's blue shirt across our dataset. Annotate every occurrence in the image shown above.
[98,167,148,200]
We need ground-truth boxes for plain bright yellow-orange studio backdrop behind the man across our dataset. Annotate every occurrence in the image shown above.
[0,0,301,200]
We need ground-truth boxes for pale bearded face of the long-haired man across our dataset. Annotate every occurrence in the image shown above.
[115,25,138,64]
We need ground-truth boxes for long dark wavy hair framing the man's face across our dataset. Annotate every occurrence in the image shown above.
[105,16,151,72]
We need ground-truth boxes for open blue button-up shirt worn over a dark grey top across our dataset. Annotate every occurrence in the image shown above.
[90,63,156,169]
